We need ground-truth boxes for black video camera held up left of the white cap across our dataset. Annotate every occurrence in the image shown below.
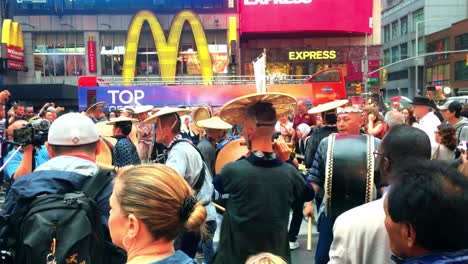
[13,119,50,147]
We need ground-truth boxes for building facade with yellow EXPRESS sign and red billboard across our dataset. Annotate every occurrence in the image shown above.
[239,0,381,95]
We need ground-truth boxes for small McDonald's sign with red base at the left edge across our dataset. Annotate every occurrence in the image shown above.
[1,19,24,70]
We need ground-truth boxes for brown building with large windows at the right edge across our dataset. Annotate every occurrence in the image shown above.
[424,19,468,95]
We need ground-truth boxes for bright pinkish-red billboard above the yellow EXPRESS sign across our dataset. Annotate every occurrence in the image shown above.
[240,0,372,34]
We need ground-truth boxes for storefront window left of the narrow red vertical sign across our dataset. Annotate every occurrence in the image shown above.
[33,32,85,76]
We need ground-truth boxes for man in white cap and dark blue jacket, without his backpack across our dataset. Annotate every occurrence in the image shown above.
[2,113,112,226]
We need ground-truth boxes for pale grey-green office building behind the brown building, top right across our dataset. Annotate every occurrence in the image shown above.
[382,0,468,97]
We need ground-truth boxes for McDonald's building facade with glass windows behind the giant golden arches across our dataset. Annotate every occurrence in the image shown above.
[0,0,237,107]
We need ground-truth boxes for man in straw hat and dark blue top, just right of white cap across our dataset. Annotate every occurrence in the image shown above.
[106,116,141,167]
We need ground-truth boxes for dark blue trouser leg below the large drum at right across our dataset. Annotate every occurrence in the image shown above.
[315,213,333,264]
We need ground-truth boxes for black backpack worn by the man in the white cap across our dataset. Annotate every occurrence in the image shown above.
[2,170,125,264]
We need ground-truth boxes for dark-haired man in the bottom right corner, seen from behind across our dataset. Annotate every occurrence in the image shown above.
[384,161,468,264]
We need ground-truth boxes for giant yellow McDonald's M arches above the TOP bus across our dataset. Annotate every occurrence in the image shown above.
[122,10,213,85]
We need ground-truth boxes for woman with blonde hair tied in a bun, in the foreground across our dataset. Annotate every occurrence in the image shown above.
[109,164,206,264]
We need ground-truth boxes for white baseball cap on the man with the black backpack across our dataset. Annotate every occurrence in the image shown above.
[47,113,99,146]
